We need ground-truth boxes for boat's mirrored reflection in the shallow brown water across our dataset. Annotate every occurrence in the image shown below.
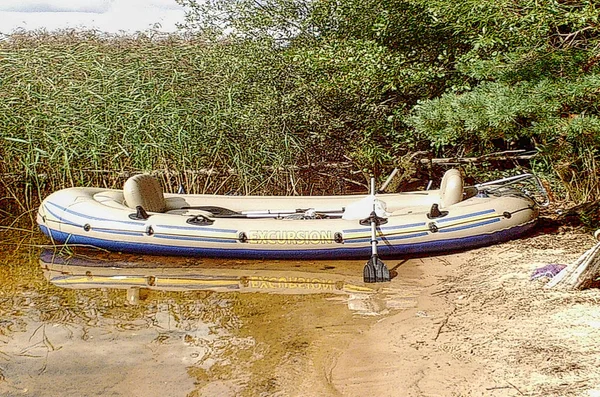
[40,249,389,315]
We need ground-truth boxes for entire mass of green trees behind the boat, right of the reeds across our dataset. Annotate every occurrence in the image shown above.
[176,0,600,200]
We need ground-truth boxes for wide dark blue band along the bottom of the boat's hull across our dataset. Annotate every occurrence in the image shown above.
[40,221,535,259]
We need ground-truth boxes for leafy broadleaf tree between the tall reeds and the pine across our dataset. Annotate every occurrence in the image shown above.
[179,0,462,170]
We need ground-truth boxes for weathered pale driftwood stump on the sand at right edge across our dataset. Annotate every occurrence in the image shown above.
[546,232,600,290]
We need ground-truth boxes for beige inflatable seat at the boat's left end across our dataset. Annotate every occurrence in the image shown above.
[123,174,167,212]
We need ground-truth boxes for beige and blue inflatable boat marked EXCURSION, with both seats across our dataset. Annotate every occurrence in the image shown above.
[37,169,541,259]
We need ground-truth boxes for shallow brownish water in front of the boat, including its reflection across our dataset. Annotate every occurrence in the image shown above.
[0,232,420,396]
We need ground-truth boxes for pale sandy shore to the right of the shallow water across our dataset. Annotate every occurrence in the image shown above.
[324,221,600,396]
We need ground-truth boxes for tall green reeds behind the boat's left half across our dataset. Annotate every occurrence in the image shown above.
[0,32,342,220]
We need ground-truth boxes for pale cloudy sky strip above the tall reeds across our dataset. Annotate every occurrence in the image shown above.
[0,0,184,34]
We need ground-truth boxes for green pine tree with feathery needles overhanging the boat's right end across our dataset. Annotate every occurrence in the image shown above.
[408,0,600,201]
